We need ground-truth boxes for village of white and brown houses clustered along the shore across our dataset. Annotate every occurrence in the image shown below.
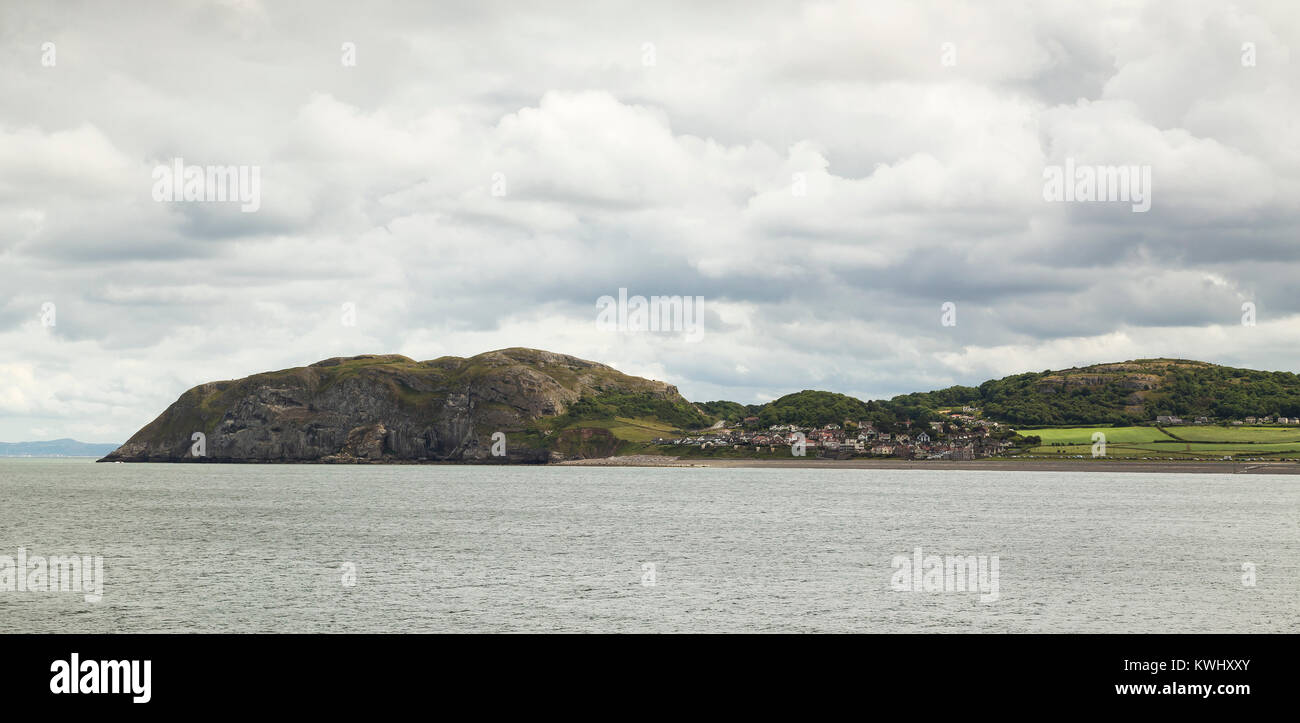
[655,414,1011,460]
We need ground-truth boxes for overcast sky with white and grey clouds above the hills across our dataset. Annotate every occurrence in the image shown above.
[0,0,1300,442]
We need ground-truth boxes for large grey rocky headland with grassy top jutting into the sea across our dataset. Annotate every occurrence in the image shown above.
[103,348,685,463]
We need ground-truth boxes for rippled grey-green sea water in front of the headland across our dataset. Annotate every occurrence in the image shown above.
[0,459,1300,632]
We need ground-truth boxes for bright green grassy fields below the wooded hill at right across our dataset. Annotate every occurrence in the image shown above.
[1019,425,1300,459]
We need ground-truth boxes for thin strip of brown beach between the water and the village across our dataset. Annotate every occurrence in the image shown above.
[549,455,1300,475]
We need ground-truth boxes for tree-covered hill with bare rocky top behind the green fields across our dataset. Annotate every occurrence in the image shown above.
[892,359,1300,425]
